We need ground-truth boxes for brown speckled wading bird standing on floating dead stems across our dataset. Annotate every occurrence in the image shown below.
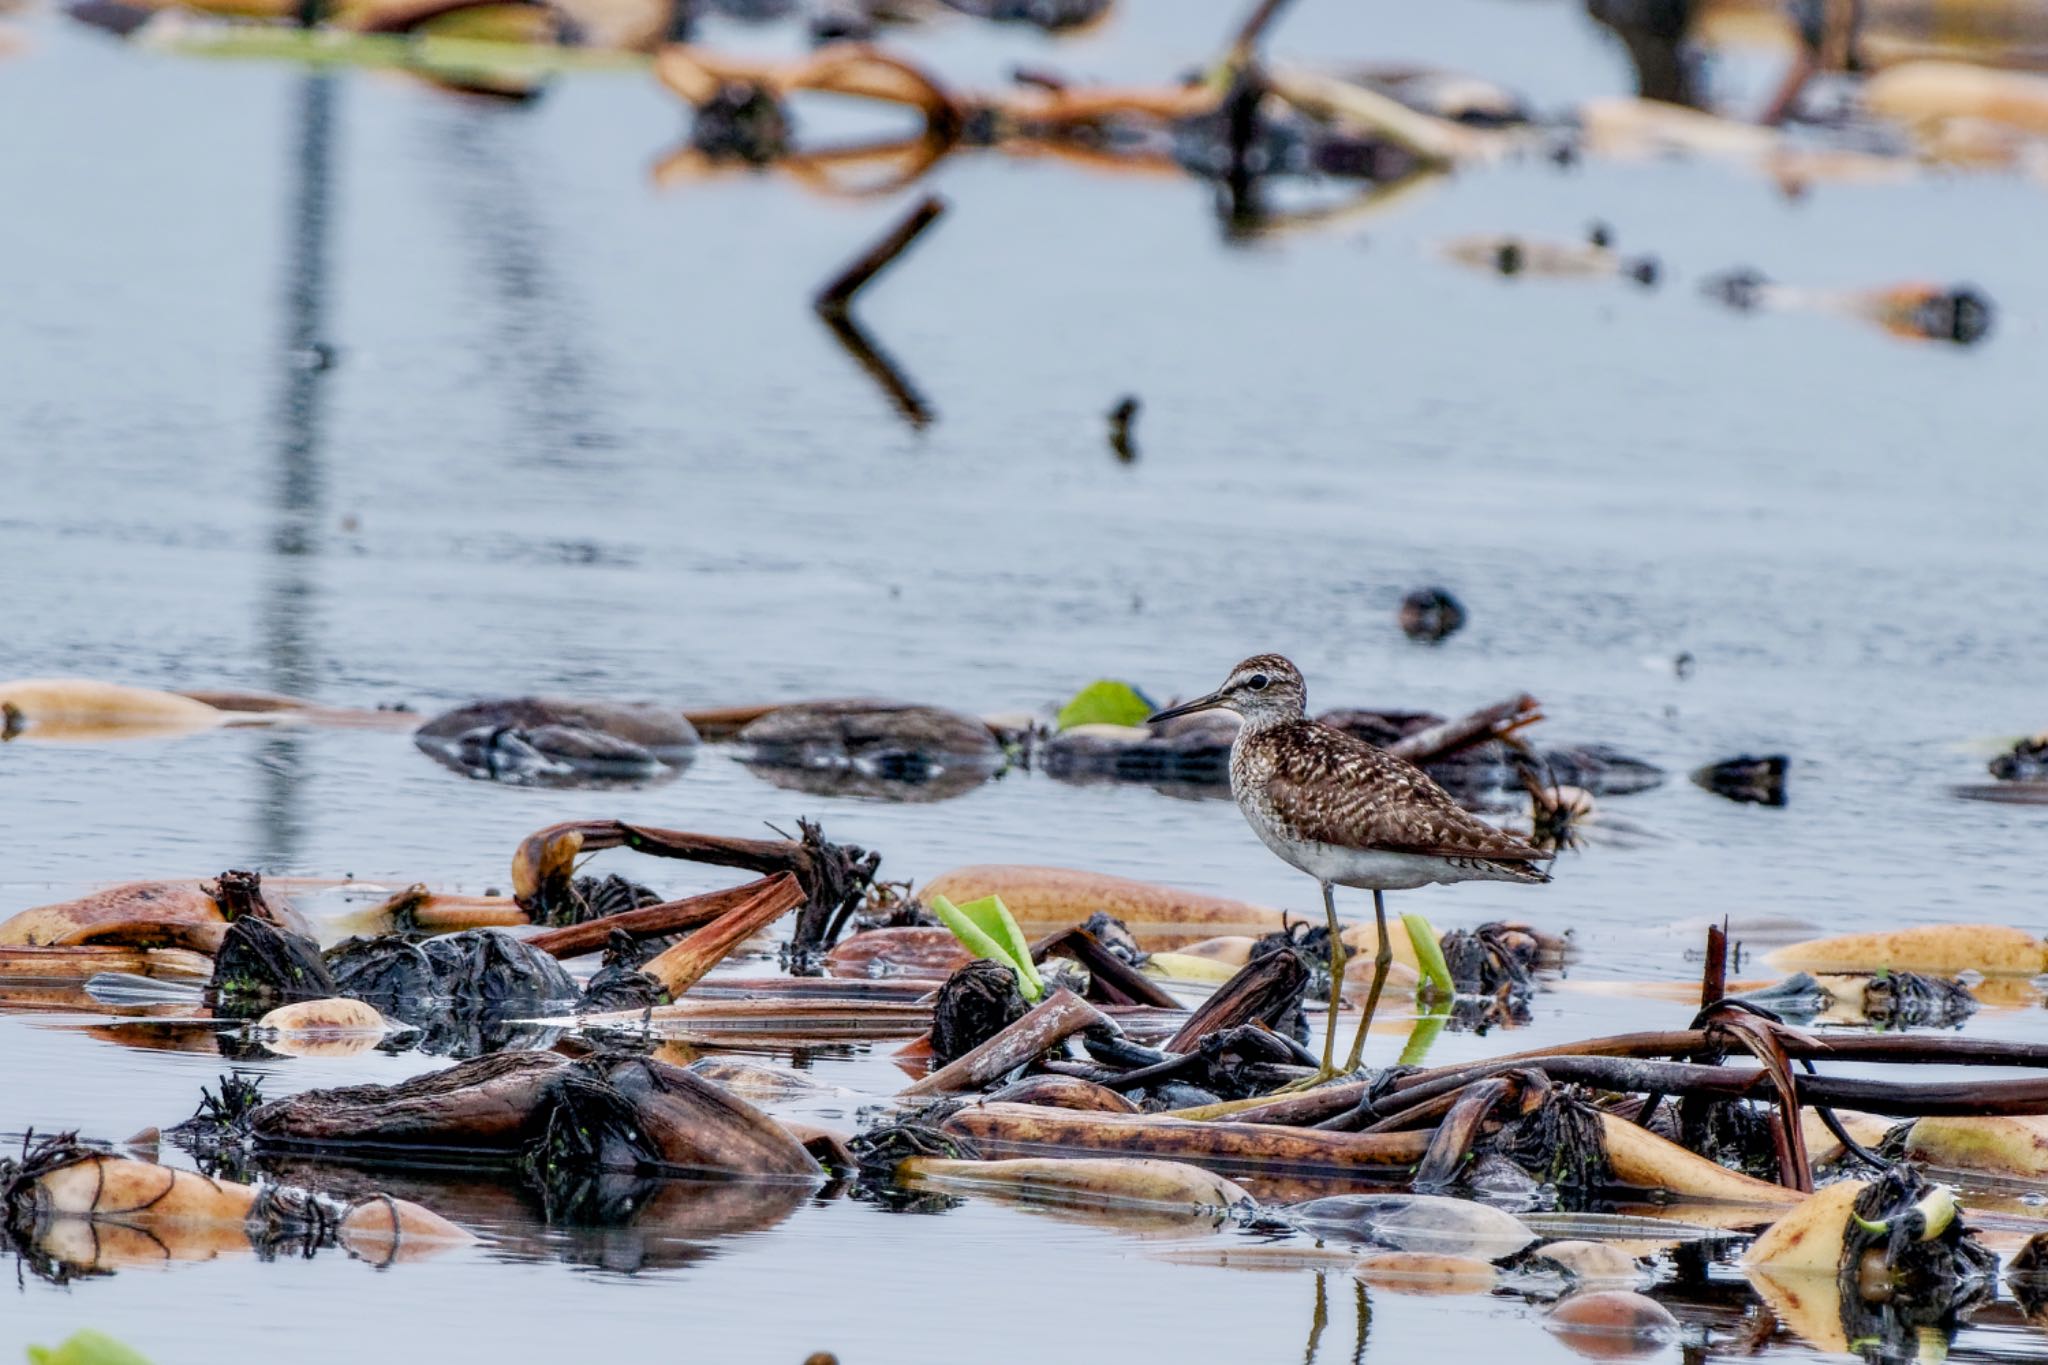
[1153,655,1550,1085]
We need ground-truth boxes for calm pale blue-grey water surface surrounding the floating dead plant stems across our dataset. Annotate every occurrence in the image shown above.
[0,0,2048,1365]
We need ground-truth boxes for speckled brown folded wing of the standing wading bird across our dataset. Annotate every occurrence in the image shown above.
[1262,720,1544,862]
